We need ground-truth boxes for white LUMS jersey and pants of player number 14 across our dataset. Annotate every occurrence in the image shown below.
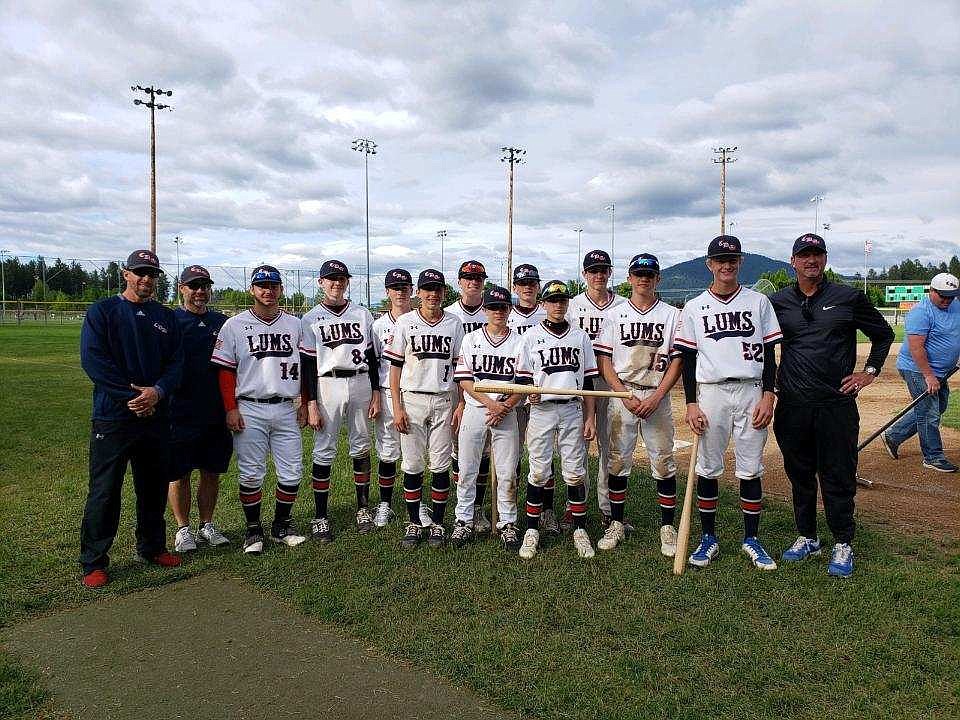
[210,310,303,490]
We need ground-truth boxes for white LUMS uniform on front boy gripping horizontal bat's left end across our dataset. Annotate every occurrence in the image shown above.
[454,328,520,528]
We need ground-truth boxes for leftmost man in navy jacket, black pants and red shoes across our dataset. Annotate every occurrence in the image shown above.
[80,250,183,588]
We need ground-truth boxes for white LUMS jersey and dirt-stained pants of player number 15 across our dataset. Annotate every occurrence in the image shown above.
[593,300,680,480]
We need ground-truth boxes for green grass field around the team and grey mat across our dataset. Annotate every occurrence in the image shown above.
[0,326,960,720]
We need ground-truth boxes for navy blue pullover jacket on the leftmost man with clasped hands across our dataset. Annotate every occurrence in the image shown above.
[80,295,183,420]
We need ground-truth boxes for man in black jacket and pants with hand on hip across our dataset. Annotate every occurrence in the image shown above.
[770,234,893,577]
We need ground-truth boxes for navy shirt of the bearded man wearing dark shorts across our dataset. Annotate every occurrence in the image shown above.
[170,307,227,427]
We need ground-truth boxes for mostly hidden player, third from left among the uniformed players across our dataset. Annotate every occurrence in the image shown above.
[373,268,413,528]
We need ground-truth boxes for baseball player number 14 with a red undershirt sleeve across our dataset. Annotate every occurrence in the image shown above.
[210,265,306,554]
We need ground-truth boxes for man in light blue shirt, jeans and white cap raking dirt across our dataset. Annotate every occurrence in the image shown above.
[881,273,960,472]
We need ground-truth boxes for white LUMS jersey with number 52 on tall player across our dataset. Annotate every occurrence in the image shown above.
[674,286,783,383]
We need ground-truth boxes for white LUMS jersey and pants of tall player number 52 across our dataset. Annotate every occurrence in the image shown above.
[675,287,783,480]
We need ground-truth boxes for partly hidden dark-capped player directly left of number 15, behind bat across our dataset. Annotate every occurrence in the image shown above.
[561,250,626,528]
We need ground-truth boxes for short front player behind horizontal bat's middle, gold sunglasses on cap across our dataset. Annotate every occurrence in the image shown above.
[517,280,597,560]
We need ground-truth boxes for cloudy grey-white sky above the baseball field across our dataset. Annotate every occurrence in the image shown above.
[0,0,960,296]
